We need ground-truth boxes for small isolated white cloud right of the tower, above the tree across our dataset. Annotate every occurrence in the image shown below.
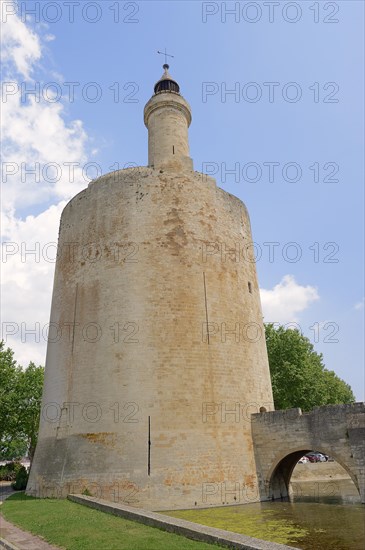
[260,275,319,324]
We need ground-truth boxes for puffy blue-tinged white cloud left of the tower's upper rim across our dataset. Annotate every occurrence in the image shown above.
[2,94,87,209]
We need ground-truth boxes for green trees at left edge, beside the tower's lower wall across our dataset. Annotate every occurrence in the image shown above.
[0,342,44,460]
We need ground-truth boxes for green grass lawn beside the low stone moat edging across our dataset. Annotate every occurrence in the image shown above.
[1,493,217,550]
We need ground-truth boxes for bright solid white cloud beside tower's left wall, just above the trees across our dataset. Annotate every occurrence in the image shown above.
[1,202,65,366]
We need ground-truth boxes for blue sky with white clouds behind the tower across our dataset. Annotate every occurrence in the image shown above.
[1,0,364,400]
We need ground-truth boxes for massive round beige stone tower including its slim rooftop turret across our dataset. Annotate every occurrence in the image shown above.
[27,65,273,510]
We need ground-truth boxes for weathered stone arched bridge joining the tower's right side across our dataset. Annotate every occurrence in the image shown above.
[252,403,365,503]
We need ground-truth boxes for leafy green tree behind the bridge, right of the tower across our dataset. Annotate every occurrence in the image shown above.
[265,324,355,411]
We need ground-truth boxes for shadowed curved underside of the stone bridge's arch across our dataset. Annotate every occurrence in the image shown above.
[265,445,361,500]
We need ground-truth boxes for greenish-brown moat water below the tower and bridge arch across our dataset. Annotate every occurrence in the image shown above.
[168,480,365,550]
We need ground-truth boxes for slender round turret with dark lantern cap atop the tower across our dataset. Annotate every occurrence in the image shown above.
[144,63,193,170]
